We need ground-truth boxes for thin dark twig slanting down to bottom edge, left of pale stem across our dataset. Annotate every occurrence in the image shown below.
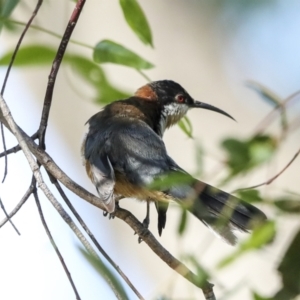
[32,177,81,300]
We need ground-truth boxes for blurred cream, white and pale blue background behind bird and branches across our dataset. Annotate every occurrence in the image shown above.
[0,0,300,300]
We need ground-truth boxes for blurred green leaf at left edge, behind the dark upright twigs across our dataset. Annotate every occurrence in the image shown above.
[0,45,56,67]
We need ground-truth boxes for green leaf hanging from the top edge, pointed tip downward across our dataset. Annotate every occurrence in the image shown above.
[120,0,153,47]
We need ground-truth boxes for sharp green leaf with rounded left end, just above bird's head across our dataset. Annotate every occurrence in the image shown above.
[94,40,154,70]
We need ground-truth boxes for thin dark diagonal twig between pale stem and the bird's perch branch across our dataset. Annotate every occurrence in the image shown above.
[49,173,144,299]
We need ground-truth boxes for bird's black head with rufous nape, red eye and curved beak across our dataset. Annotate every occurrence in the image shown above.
[135,80,234,133]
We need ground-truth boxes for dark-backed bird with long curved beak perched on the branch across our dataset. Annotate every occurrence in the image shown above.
[81,80,267,245]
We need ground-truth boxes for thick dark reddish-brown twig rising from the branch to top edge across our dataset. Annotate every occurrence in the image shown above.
[38,0,85,149]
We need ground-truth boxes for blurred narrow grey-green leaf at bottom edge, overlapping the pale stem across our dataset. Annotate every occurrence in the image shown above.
[79,248,129,300]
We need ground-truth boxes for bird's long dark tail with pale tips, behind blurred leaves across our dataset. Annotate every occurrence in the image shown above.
[170,180,267,245]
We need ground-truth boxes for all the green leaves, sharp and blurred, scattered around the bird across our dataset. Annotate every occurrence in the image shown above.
[0,0,300,300]
